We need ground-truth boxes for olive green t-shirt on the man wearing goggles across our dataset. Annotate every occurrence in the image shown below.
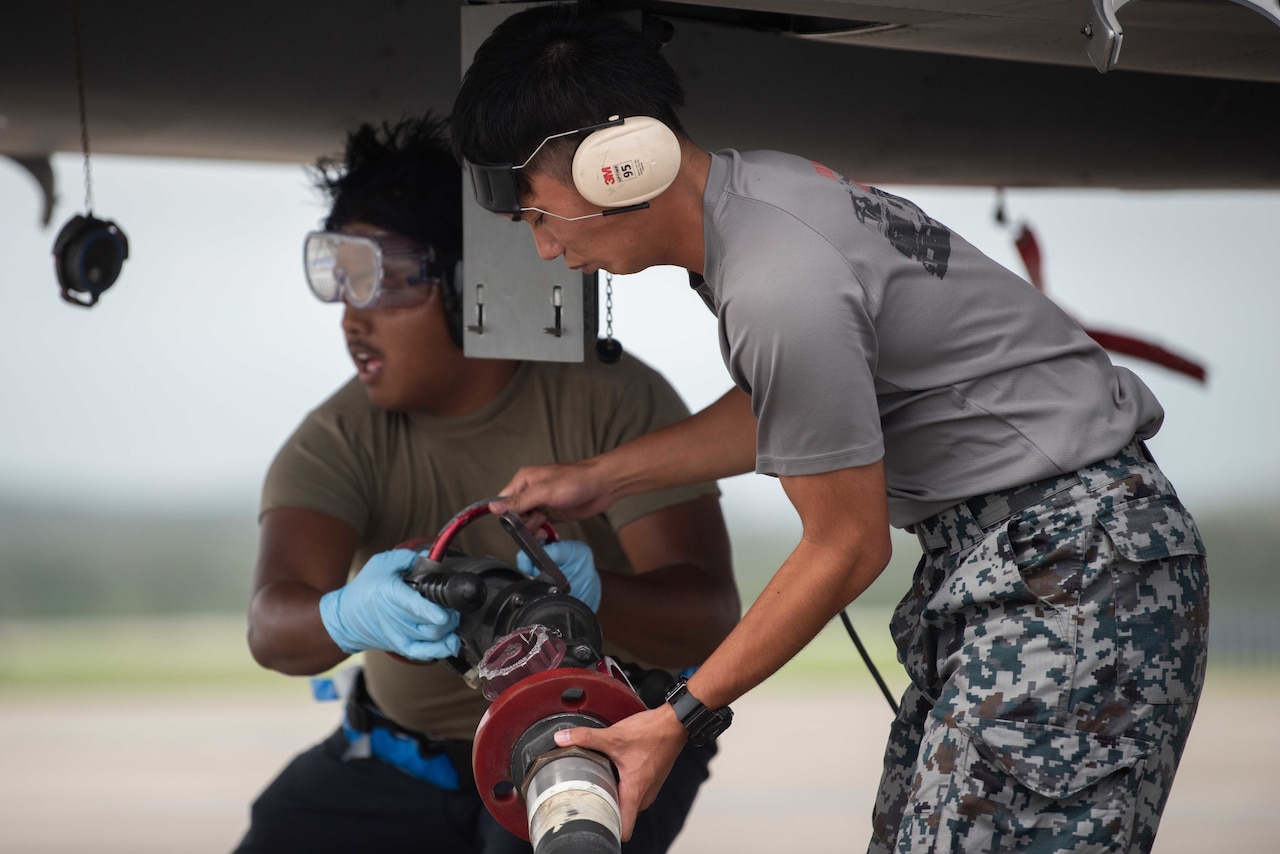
[261,356,717,739]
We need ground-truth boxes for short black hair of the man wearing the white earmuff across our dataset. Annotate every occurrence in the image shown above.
[452,4,687,181]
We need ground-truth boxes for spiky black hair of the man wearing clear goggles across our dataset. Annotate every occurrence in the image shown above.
[311,113,462,266]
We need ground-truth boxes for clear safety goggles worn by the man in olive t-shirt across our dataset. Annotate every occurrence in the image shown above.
[302,232,443,309]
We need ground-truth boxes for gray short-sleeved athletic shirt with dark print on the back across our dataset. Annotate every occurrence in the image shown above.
[699,150,1164,528]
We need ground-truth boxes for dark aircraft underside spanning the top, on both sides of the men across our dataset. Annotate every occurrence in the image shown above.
[0,0,1280,188]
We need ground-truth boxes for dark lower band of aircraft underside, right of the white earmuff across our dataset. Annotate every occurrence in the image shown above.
[666,15,1280,188]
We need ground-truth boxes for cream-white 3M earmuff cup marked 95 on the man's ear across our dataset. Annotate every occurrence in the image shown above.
[573,115,680,207]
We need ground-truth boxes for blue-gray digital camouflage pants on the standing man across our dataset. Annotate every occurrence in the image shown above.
[869,443,1208,854]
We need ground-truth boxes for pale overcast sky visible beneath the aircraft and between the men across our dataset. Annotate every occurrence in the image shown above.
[0,155,1280,521]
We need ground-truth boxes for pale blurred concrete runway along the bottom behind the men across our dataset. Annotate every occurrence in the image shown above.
[0,675,1264,854]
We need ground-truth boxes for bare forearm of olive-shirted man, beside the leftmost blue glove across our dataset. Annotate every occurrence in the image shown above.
[248,581,347,676]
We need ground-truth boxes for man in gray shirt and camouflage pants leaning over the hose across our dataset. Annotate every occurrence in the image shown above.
[453,6,1208,853]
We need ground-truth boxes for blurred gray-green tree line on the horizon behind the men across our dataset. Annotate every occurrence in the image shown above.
[0,502,1280,620]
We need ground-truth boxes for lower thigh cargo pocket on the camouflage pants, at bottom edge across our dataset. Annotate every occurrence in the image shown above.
[936,720,1147,854]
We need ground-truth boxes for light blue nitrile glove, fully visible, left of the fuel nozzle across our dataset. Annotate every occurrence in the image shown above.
[320,548,461,661]
